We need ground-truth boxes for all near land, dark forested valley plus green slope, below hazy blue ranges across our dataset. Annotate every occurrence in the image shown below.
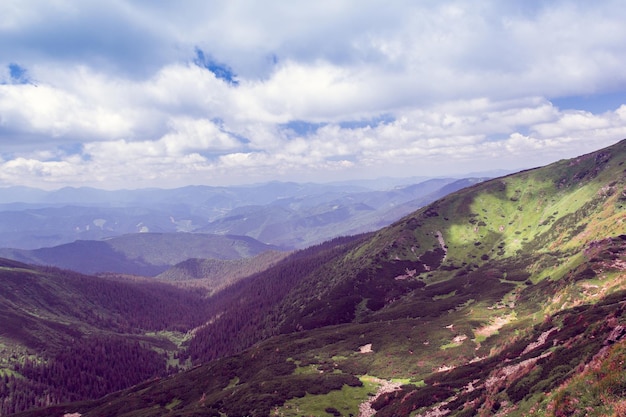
[0,140,626,417]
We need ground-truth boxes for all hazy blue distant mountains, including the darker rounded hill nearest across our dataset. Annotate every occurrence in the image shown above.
[0,177,485,276]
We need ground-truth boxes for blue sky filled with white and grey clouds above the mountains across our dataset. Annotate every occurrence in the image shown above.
[0,0,626,189]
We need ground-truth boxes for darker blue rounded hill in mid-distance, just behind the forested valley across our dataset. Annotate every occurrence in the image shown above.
[0,233,278,276]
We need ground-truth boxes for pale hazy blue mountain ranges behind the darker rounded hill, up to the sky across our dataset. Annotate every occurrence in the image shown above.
[0,178,482,249]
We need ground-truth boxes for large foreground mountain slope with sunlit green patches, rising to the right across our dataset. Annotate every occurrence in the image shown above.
[8,140,626,417]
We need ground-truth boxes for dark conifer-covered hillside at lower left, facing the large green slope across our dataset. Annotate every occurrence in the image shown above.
[0,260,208,415]
